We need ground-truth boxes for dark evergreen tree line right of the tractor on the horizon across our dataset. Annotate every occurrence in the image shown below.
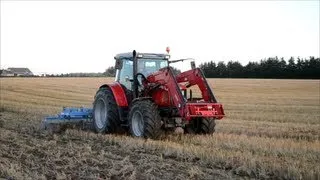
[199,57,320,79]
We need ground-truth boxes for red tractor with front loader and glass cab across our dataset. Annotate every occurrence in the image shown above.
[92,51,224,138]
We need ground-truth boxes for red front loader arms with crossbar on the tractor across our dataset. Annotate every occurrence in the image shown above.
[145,68,224,120]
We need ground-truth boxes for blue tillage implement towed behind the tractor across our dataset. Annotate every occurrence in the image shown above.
[42,107,92,127]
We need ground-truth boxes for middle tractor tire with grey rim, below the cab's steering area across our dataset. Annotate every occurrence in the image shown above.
[128,99,161,139]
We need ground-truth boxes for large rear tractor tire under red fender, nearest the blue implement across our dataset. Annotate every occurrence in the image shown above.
[93,87,119,133]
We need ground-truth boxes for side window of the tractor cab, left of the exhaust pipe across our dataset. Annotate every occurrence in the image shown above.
[119,60,133,89]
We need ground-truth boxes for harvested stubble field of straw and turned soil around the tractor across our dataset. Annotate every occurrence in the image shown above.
[0,78,320,179]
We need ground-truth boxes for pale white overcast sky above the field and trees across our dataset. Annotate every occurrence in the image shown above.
[1,1,320,74]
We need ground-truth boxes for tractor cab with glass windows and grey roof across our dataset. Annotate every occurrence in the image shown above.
[114,52,170,90]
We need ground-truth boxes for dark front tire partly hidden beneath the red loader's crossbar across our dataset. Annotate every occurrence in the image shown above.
[185,118,216,134]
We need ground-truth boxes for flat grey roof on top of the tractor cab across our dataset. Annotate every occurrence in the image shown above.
[114,52,170,61]
